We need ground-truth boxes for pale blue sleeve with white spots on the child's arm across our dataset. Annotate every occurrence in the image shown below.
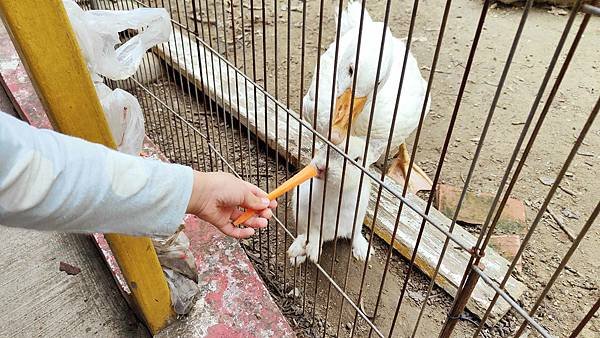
[0,112,193,235]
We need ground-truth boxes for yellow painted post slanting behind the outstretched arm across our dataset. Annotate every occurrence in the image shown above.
[0,0,174,333]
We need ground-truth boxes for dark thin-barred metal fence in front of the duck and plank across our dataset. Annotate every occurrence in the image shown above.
[87,0,600,337]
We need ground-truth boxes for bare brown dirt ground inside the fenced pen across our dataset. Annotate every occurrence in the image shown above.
[118,0,600,337]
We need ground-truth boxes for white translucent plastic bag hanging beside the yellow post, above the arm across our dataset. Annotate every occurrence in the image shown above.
[63,0,171,155]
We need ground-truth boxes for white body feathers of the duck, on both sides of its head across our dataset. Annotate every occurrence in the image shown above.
[303,2,431,161]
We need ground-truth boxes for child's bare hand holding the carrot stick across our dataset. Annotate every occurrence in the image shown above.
[186,171,277,238]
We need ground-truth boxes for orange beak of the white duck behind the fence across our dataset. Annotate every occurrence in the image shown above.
[331,88,367,144]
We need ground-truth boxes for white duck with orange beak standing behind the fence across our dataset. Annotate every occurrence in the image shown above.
[303,2,432,192]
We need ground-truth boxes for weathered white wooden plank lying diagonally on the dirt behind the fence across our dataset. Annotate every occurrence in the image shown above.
[155,30,526,324]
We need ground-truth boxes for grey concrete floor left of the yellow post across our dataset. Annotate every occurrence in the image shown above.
[0,86,149,337]
